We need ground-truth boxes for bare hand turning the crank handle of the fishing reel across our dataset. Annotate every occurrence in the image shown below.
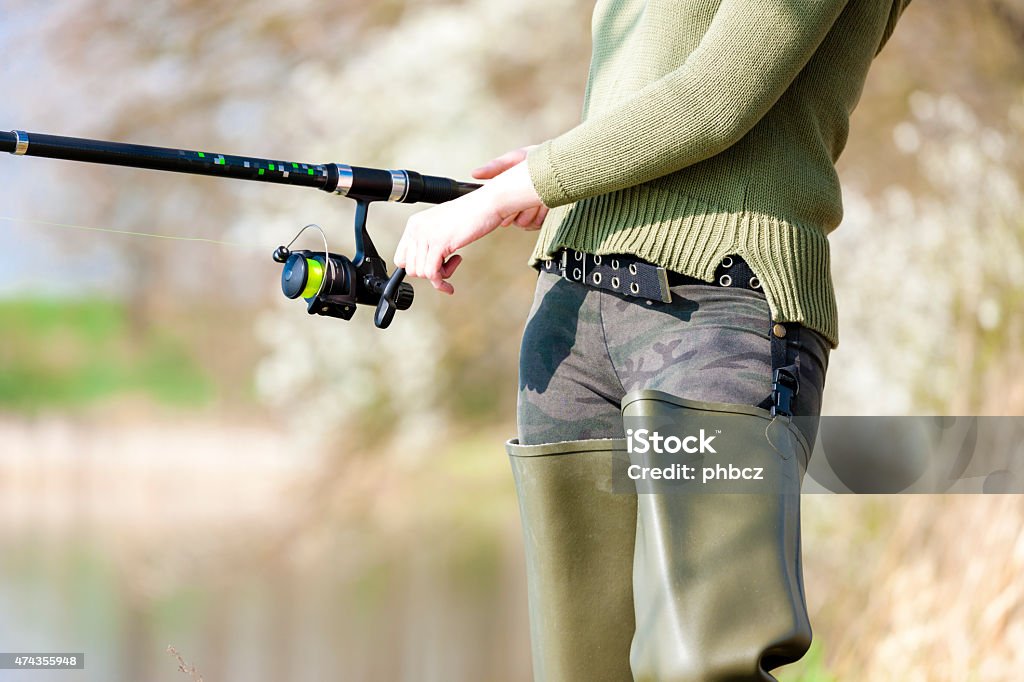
[394,154,547,294]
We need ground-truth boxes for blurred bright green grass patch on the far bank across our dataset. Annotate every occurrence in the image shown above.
[0,300,213,412]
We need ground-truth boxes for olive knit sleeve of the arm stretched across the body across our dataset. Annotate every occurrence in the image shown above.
[527,0,847,206]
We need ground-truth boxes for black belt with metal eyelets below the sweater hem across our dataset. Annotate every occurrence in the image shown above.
[538,249,762,303]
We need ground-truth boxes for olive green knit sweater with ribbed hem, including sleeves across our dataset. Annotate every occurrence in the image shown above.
[528,0,910,346]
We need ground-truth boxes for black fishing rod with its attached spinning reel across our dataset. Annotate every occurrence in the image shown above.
[0,130,480,329]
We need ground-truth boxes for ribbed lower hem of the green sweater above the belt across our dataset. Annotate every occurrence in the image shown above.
[529,185,839,348]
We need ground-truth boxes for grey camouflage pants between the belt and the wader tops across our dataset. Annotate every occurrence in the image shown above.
[517,272,829,444]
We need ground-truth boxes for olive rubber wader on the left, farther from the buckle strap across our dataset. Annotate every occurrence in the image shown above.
[507,439,637,682]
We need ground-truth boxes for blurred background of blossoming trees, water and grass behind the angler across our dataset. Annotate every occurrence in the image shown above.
[0,0,1024,682]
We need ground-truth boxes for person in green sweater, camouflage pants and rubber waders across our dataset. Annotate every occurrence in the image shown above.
[395,0,909,680]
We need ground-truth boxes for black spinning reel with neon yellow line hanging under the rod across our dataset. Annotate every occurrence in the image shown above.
[273,200,415,329]
